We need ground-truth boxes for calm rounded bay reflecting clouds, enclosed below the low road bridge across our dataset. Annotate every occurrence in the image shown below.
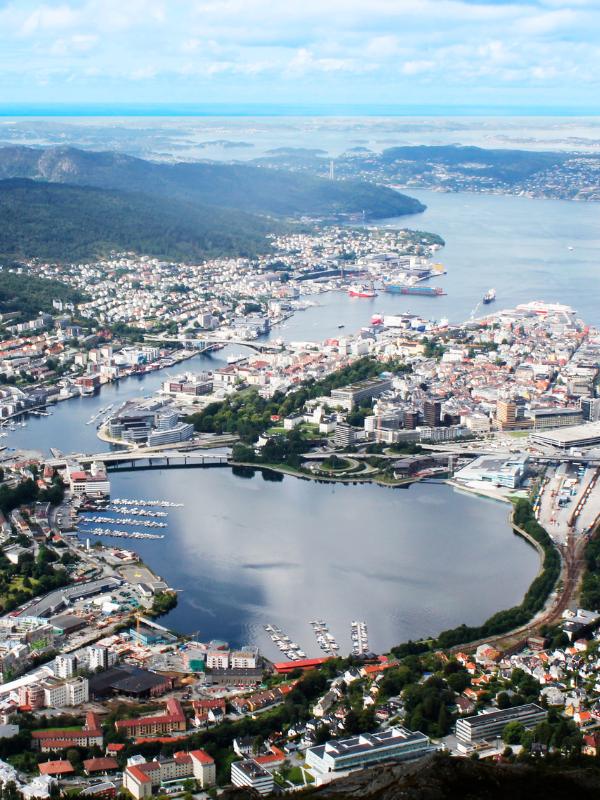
[95,469,538,656]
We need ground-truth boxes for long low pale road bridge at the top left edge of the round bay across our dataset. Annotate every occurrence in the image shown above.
[46,450,229,472]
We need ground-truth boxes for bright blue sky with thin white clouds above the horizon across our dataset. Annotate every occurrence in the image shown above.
[0,0,600,112]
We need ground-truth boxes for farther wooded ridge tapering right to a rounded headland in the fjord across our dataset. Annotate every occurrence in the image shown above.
[0,146,424,218]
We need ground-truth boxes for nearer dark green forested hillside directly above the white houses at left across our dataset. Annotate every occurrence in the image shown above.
[0,179,277,261]
